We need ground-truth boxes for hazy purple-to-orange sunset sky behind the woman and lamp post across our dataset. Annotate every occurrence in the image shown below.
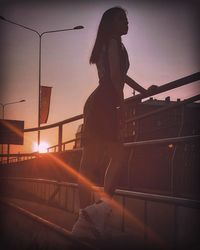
[0,0,200,152]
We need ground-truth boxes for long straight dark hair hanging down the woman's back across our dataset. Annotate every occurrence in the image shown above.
[89,7,126,64]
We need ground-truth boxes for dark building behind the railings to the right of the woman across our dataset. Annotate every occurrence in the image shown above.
[125,97,200,141]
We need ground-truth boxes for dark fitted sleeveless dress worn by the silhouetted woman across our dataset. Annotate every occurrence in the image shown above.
[83,38,129,144]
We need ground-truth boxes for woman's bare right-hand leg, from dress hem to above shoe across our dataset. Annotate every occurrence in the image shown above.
[104,142,124,198]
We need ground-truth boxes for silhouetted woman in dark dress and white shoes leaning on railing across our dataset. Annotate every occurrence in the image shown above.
[72,7,146,238]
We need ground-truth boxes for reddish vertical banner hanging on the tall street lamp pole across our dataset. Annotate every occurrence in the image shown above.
[40,86,52,124]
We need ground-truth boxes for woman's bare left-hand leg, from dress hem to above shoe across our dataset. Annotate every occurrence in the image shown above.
[79,143,103,208]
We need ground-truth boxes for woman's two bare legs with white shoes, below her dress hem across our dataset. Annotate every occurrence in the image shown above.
[72,143,123,236]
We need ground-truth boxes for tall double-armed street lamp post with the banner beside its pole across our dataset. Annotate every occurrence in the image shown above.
[0,16,84,146]
